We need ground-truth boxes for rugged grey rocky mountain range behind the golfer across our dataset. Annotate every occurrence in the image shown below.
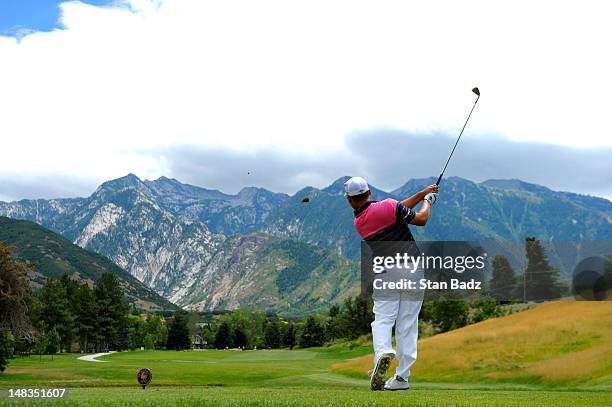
[0,174,612,309]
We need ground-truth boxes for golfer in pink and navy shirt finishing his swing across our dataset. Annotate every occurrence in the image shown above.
[344,177,438,390]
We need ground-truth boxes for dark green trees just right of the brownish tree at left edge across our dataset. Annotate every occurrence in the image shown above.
[16,273,167,355]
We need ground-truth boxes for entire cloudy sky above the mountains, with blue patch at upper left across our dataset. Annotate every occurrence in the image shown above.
[0,0,612,200]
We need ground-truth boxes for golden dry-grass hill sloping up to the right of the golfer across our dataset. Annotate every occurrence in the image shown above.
[332,301,612,390]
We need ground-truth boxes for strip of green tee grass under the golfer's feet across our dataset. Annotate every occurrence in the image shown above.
[2,386,612,407]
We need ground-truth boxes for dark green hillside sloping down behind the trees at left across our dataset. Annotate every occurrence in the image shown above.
[0,216,177,310]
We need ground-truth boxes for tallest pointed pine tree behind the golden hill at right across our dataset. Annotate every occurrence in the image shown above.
[524,237,562,301]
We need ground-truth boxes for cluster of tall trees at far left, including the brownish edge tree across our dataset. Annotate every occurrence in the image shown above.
[0,242,168,371]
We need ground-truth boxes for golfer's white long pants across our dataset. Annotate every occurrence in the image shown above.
[372,293,423,380]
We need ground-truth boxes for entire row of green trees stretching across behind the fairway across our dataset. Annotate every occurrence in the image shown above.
[0,238,612,371]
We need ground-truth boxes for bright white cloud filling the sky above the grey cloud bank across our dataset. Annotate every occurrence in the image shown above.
[0,0,612,197]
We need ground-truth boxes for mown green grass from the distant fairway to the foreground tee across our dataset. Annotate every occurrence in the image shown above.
[0,347,612,406]
